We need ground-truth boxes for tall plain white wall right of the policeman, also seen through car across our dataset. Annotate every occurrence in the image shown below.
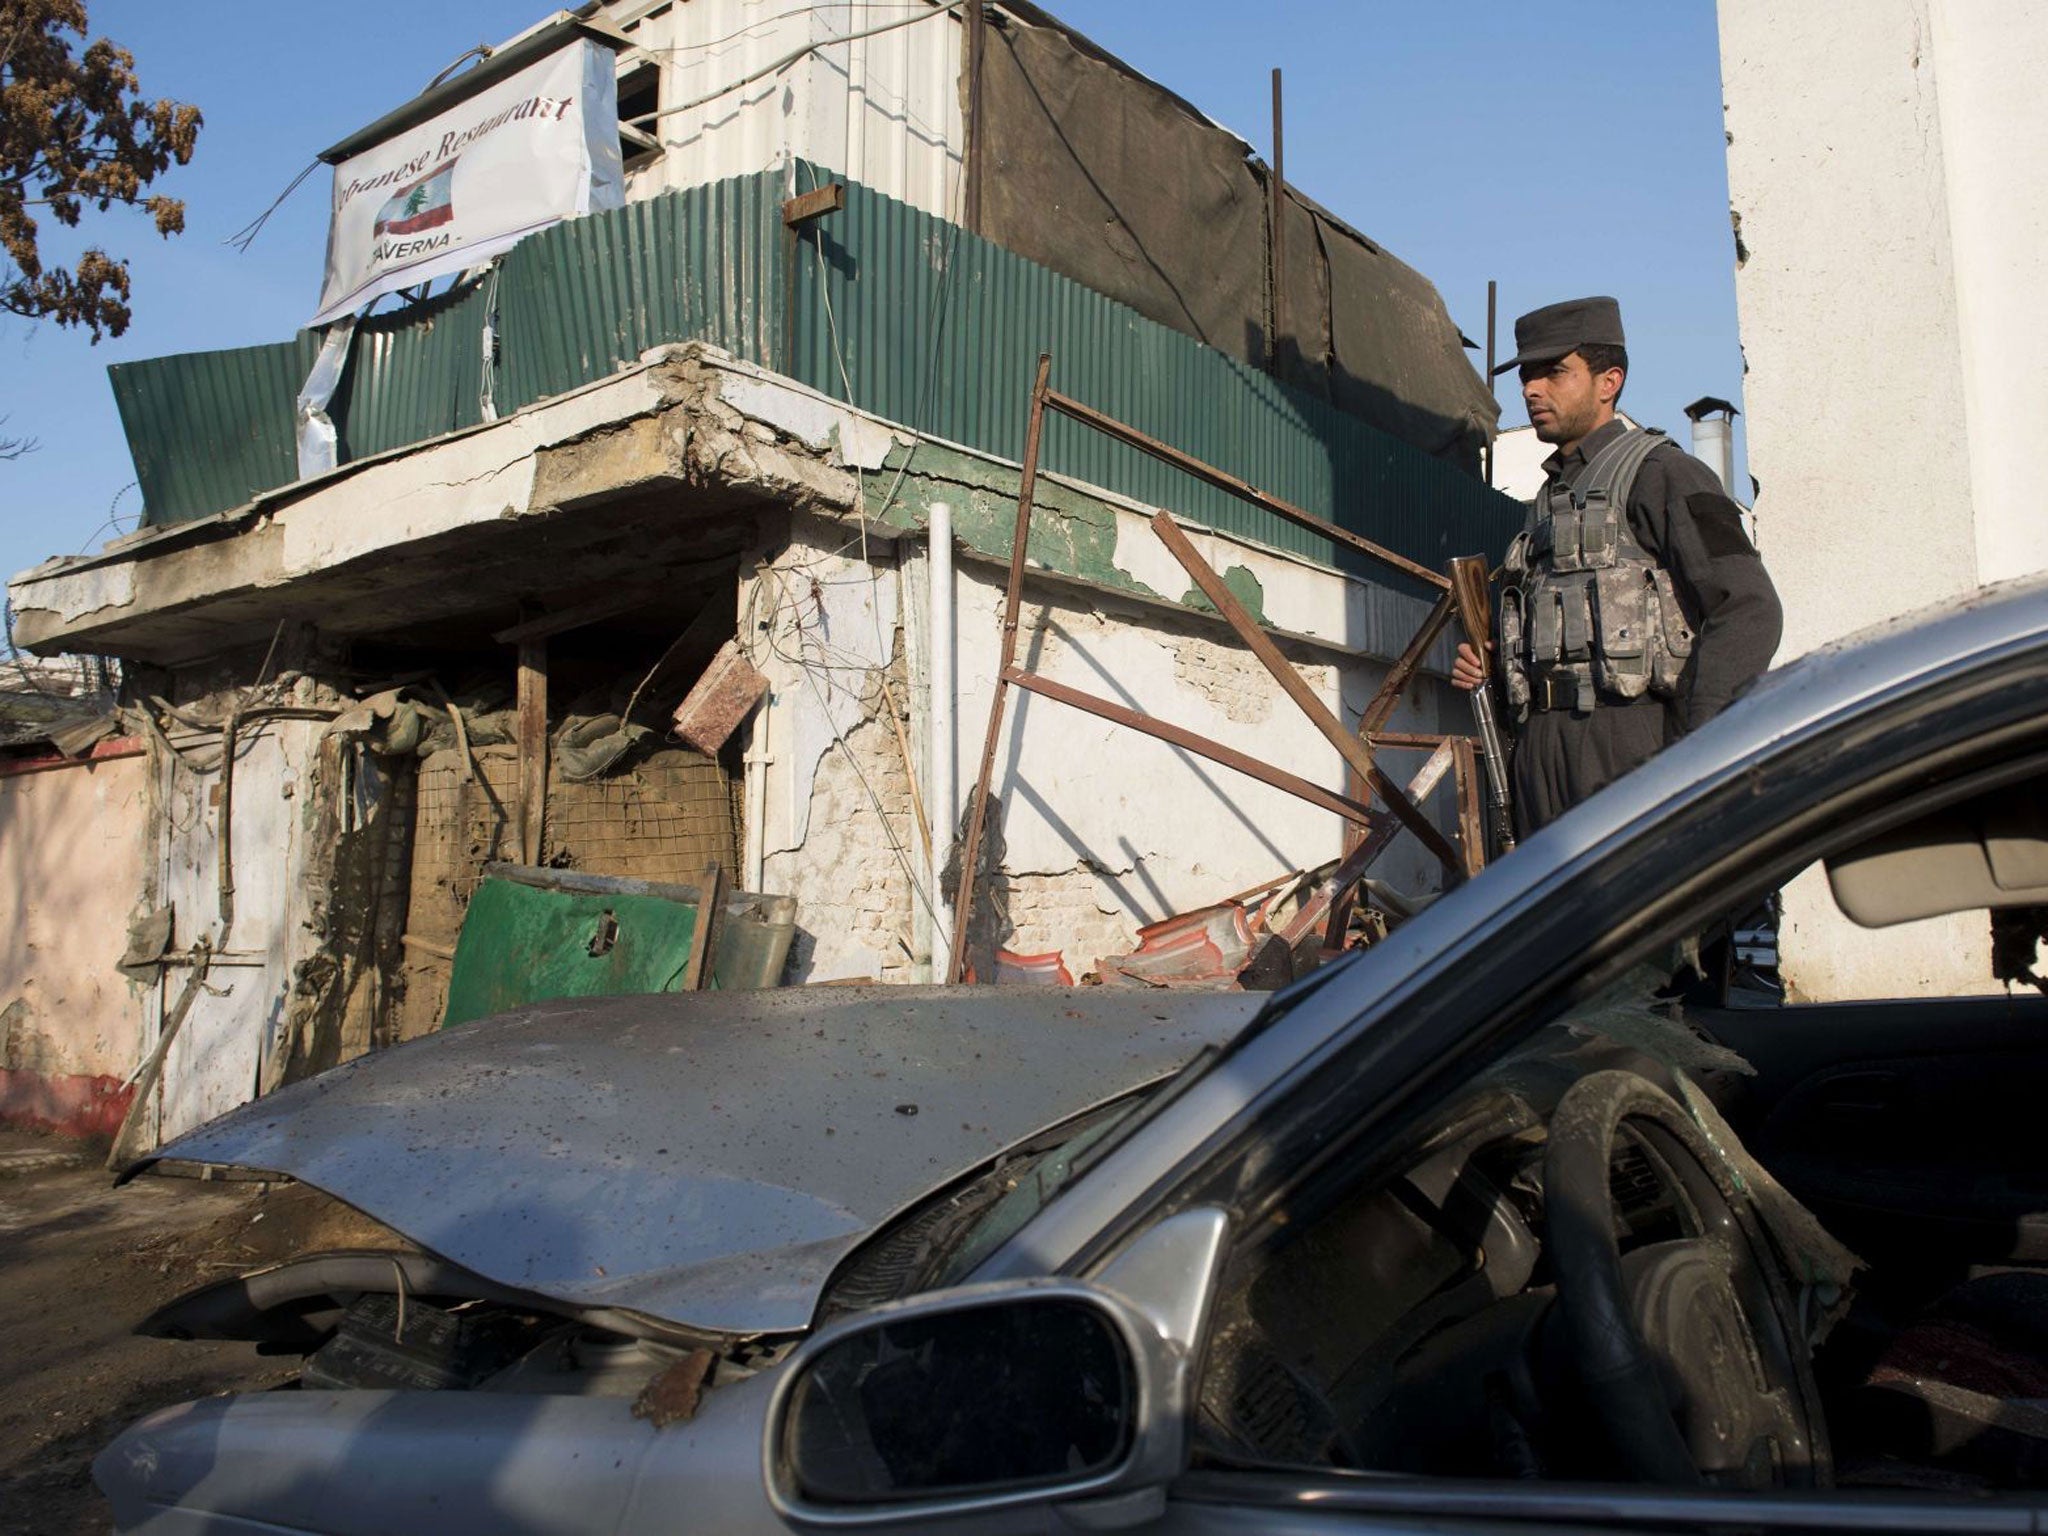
[1718,0,2048,997]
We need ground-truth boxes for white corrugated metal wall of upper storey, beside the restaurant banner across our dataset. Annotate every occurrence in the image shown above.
[604,0,963,217]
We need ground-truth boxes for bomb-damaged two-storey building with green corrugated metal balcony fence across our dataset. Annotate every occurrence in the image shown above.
[0,0,1522,1147]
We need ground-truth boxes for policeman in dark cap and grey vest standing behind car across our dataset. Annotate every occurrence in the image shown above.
[1452,299,1784,836]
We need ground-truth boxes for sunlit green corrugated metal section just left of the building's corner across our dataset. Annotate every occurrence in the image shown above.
[498,176,784,410]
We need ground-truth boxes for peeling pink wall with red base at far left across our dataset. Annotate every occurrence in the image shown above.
[0,756,150,1130]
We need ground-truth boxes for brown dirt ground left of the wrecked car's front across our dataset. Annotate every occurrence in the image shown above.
[0,1130,397,1536]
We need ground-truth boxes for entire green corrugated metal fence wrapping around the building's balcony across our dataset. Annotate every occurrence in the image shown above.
[115,172,1522,565]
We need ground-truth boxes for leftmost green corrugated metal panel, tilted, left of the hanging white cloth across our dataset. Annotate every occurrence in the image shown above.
[106,334,319,524]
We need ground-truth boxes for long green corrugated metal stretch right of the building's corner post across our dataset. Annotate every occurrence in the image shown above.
[791,169,1522,565]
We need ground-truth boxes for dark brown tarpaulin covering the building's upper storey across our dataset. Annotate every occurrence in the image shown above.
[963,4,1499,473]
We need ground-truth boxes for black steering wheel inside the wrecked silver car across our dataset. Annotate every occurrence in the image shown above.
[1544,1071,1833,1487]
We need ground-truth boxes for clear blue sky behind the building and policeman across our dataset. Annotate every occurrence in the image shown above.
[0,0,1743,593]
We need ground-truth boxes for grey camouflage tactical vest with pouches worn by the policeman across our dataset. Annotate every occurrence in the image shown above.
[1501,428,1692,713]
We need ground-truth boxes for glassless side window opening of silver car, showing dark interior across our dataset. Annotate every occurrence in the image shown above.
[1194,847,2048,1493]
